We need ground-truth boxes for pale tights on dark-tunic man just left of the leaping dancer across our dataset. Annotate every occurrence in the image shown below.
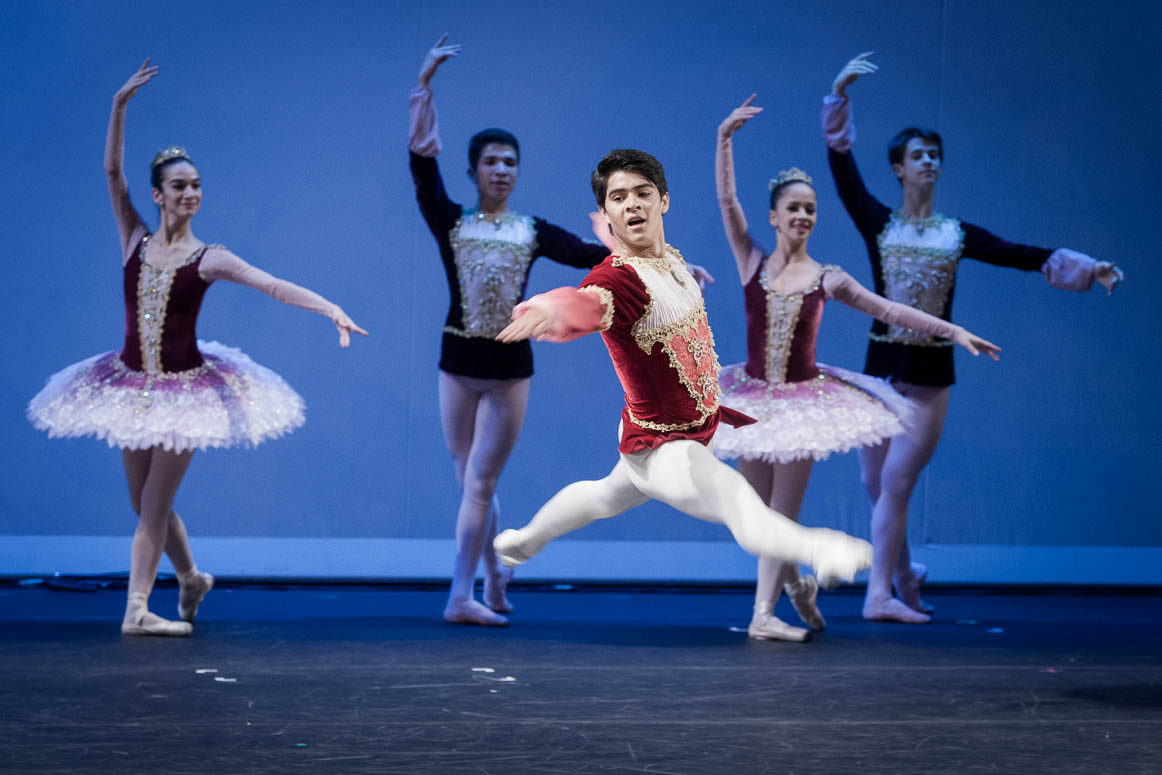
[439,371,529,600]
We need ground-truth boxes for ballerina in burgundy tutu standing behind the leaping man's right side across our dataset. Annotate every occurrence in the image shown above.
[715,94,999,640]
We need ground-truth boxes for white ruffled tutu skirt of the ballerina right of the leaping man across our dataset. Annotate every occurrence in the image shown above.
[713,364,912,462]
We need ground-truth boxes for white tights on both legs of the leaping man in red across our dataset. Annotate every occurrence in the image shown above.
[506,439,812,562]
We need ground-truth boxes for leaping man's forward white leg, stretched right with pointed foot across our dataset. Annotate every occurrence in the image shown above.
[622,439,872,584]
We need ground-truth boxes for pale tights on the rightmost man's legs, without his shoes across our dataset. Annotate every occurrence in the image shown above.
[860,381,948,610]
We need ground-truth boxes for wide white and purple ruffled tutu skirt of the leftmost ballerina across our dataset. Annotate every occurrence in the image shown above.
[28,340,304,452]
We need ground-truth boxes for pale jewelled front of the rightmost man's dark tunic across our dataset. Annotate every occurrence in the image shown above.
[878,213,964,345]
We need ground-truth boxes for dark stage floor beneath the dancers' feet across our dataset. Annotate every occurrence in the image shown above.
[0,582,1162,775]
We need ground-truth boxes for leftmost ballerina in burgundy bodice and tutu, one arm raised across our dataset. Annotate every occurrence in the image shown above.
[28,59,367,636]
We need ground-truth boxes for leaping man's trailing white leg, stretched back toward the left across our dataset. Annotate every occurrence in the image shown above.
[494,455,650,567]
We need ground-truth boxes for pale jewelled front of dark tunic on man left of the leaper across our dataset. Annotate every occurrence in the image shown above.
[445,213,536,339]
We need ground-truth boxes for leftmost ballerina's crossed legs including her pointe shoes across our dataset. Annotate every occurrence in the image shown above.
[121,447,194,636]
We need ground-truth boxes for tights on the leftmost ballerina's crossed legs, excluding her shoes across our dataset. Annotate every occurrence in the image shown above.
[121,446,194,613]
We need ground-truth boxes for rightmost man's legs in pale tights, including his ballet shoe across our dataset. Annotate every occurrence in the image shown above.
[860,382,949,624]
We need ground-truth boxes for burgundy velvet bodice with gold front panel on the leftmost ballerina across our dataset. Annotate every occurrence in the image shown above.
[121,239,210,372]
